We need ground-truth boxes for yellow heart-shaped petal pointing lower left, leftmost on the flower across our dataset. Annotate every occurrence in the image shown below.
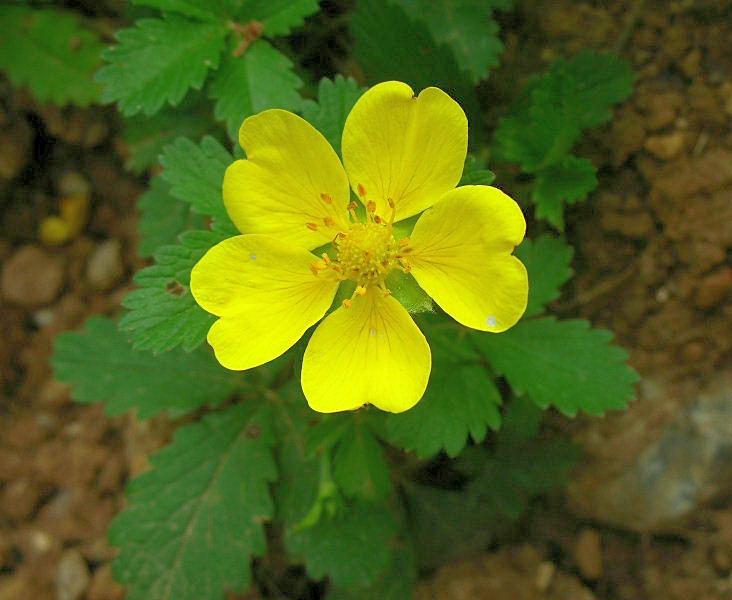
[191,234,338,371]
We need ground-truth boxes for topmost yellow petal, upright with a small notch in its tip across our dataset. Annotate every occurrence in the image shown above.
[343,81,468,220]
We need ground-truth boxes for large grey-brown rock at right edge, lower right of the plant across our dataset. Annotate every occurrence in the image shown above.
[568,370,732,532]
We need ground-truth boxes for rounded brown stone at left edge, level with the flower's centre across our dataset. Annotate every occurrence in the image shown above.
[0,245,65,306]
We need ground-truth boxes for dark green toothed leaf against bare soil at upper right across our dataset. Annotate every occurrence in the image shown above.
[494,51,633,229]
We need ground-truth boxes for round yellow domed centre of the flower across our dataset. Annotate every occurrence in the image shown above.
[334,223,399,287]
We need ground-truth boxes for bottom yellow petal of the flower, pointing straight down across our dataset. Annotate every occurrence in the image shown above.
[302,288,432,413]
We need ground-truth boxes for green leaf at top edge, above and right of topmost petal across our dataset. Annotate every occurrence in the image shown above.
[397,0,503,83]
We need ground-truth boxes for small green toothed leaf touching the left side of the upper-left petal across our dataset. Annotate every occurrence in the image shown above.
[160,136,234,223]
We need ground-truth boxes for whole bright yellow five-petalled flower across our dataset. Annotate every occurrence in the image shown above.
[191,81,528,412]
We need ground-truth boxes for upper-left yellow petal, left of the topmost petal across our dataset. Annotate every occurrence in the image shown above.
[224,109,350,249]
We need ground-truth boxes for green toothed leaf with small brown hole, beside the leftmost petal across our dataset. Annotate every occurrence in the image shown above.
[119,231,228,353]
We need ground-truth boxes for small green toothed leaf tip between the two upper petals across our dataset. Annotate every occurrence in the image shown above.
[302,75,366,154]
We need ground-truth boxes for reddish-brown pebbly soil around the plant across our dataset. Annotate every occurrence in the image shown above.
[0,0,732,600]
